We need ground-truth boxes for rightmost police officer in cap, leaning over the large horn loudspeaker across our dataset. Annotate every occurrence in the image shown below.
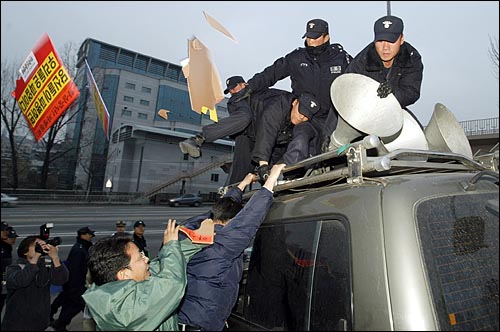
[346,16,424,121]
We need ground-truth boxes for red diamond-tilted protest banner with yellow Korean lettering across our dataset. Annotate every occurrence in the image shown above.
[15,33,80,141]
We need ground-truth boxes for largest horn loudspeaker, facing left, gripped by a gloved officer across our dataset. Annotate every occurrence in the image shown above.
[329,73,404,150]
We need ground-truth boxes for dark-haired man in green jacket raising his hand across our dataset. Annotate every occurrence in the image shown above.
[83,219,203,331]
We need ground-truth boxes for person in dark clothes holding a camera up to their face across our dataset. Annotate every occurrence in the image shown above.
[1,235,69,331]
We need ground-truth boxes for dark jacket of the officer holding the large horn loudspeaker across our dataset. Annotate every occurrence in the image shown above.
[346,42,424,108]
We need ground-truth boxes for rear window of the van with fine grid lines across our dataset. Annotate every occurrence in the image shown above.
[417,194,499,331]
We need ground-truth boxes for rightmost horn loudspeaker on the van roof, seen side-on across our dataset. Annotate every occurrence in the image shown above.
[424,103,472,159]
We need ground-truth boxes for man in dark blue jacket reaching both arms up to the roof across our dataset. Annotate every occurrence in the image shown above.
[178,164,285,331]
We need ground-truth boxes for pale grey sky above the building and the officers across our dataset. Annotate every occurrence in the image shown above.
[1,1,499,125]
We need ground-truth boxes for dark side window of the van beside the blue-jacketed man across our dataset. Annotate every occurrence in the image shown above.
[236,220,351,331]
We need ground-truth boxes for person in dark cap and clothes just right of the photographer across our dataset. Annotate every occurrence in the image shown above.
[51,227,95,331]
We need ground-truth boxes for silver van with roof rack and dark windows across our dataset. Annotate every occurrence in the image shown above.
[227,144,499,331]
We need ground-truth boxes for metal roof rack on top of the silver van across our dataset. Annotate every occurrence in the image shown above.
[219,135,492,197]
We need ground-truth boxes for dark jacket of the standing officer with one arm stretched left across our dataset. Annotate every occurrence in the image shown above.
[248,42,352,127]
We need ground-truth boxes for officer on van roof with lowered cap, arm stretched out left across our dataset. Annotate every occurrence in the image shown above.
[247,19,352,174]
